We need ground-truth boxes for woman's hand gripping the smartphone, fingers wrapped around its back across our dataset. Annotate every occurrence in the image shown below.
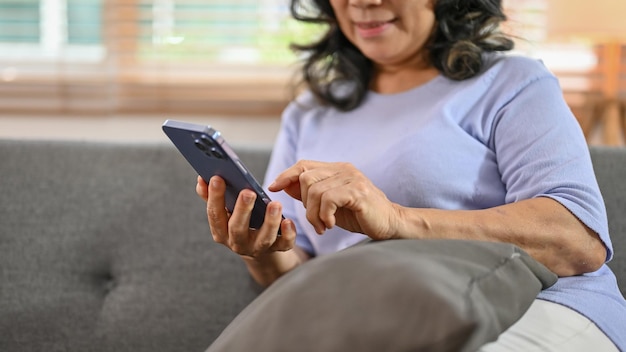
[196,176,296,259]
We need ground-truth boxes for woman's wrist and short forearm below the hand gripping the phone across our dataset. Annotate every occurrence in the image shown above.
[241,247,310,287]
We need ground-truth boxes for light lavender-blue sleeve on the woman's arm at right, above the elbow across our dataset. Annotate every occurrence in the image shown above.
[491,74,613,260]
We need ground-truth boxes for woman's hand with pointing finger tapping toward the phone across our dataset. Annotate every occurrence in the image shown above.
[269,160,401,240]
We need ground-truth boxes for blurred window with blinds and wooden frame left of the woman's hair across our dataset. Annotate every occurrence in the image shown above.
[0,0,317,114]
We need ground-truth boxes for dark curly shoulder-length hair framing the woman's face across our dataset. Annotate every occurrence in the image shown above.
[290,0,514,111]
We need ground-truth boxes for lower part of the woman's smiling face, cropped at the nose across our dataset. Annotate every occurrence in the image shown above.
[330,0,435,66]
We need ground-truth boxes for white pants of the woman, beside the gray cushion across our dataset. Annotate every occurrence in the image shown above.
[478,299,618,352]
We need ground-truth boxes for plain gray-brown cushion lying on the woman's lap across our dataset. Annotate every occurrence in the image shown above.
[207,240,556,352]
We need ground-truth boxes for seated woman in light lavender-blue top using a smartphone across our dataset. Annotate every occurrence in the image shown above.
[197,0,626,351]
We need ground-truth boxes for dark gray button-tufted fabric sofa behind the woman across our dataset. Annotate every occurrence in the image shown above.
[0,140,626,352]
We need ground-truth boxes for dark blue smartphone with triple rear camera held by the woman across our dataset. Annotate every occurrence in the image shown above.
[162,120,270,229]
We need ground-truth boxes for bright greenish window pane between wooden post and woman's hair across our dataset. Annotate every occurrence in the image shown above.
[139,0,321,64]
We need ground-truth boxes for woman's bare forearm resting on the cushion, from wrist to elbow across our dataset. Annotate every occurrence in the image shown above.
[394,197,606,276]
